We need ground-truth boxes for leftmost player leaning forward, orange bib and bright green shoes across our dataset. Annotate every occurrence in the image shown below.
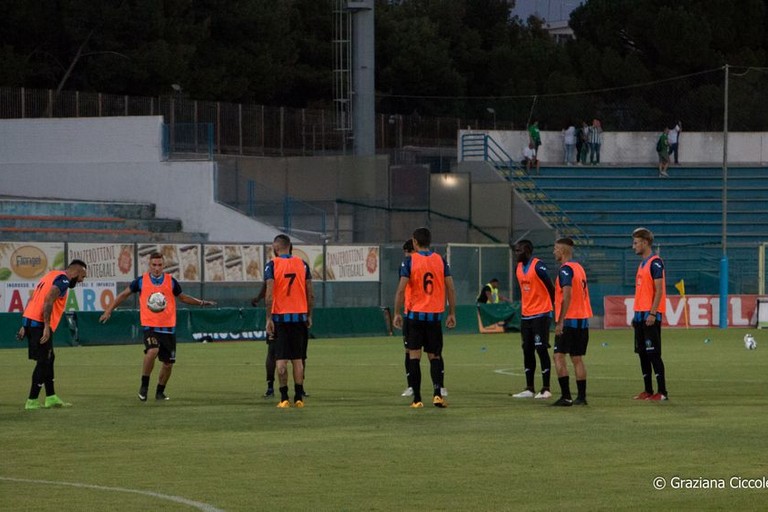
[16,260,88,410]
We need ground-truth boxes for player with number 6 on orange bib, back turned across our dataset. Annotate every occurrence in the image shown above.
[392,228,456,408]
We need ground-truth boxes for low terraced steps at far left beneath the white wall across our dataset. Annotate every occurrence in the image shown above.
[0,197,207,243]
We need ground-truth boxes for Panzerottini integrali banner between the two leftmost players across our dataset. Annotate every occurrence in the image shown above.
[67,242,136,282]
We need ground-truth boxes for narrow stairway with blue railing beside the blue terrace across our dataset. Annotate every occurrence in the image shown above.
[461,133,591,245]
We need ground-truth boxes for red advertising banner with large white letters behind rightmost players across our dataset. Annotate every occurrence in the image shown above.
[603,295,758,329]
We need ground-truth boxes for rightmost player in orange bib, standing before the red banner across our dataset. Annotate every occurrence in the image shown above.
[632,228,668,400]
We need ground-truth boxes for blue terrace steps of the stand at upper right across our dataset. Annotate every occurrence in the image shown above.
[532,166,768,247]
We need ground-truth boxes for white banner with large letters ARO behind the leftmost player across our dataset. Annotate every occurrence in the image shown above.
[0,280,117,313]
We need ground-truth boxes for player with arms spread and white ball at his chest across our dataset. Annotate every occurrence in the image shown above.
[99,252,216,402]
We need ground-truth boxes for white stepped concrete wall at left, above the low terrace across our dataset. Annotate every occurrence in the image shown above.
[0,116,286,242]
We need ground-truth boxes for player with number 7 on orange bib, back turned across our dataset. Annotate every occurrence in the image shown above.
[264,235,315,409]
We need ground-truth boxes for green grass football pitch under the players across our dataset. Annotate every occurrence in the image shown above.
[0,329,768,512]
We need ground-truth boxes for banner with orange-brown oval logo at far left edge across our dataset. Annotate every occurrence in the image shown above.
[0,242,64,281]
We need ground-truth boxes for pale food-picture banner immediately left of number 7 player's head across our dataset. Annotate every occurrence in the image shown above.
[205,244,264,283]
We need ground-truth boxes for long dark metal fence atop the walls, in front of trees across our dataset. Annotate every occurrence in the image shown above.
[0,87,512,156]
